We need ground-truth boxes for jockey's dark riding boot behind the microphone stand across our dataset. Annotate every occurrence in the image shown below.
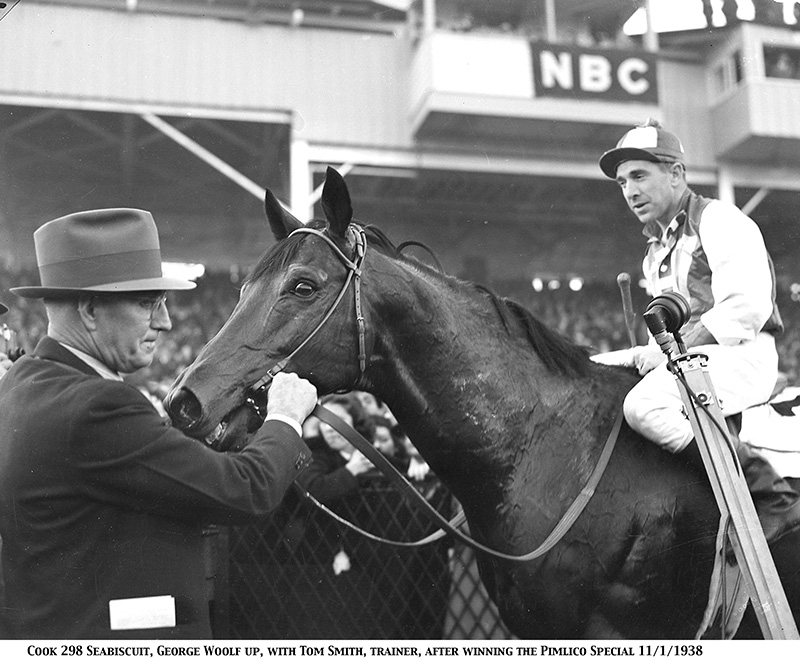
[680,436,800,543]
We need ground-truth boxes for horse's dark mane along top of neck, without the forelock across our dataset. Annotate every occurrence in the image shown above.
[364,225,590,377]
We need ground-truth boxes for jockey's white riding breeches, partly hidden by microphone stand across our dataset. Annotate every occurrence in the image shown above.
[623,332,778,453]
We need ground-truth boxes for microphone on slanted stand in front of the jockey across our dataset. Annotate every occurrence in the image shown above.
[644,292,800,639]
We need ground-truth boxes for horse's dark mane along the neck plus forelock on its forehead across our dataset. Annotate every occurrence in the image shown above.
[246,220,590,377]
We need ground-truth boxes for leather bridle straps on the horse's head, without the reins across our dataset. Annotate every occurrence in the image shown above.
[245,224,367,419]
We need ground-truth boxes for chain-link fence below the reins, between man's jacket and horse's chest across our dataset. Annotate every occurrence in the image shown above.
[208,475,510,639]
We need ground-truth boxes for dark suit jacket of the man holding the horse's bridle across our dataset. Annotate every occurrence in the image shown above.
[0,338,310,639]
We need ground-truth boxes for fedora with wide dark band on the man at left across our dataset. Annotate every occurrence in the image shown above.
[11,209,195,298]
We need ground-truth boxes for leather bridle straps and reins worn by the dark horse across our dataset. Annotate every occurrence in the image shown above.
[245,224,623,562]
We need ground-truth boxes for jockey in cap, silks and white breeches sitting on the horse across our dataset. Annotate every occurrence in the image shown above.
[595,120,800,541]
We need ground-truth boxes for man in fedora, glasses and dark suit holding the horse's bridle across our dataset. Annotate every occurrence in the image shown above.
[0,209,316,639]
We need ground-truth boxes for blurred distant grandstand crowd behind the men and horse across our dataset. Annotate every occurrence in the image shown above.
[0,260,800,397]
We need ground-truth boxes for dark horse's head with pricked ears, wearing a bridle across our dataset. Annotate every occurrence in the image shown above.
[167,168,366,444]
